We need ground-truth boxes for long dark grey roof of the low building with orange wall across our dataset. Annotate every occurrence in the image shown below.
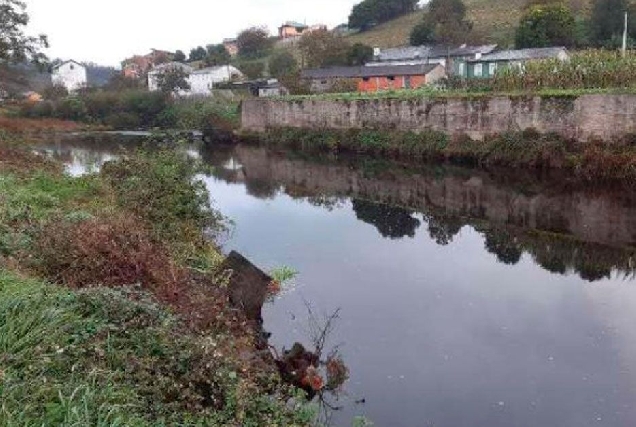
[301,64,441,79]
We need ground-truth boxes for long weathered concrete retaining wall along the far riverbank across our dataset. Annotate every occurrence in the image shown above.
[242,95,636,140]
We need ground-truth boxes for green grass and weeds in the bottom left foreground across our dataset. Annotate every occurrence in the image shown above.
[0,270,311,426]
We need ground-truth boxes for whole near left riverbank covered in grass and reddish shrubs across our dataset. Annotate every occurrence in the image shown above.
[0,143,313,426]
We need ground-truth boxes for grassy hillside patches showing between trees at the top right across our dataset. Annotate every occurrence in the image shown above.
[349,0,591,48]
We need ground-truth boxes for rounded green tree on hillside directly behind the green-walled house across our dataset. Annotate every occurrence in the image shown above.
[515,3,576,49]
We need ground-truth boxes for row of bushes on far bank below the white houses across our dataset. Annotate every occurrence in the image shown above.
[20,89,238,130]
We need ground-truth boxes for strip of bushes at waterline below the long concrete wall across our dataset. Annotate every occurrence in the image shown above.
[243,128,636,183]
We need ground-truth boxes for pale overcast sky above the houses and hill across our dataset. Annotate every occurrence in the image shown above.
[26,0,360,65]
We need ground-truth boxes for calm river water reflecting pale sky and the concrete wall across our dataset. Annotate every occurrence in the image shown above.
[33,141,636,427]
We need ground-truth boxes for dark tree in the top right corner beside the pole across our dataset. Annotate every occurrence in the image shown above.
[591,0,628,46]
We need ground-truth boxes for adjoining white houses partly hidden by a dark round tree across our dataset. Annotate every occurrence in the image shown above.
[148,62,243,96]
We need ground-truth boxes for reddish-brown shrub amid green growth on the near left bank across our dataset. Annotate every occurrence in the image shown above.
[36,215,183,295]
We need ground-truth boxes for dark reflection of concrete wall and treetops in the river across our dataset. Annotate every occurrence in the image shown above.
[204,147,636,281]
